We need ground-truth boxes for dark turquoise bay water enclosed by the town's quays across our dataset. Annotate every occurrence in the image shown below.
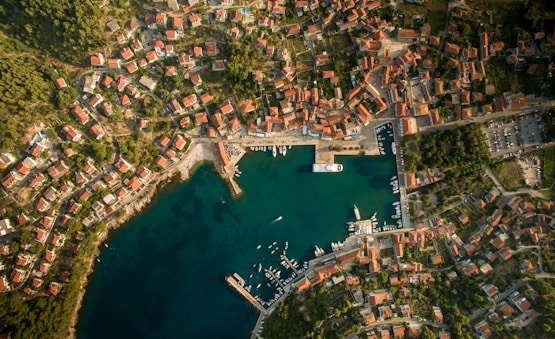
[77,146,396,338]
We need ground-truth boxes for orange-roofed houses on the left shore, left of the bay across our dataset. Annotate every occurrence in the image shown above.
[0,120,193,295]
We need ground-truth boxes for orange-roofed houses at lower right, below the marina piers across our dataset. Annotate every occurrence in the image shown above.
[288,183,555,338]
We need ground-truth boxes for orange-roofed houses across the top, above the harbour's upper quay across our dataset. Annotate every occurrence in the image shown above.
[88,0,553,145]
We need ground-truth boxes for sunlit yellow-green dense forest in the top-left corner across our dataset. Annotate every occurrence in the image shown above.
[0,0,105,63]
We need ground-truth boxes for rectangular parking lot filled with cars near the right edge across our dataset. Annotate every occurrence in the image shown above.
[482,112,543,158]
